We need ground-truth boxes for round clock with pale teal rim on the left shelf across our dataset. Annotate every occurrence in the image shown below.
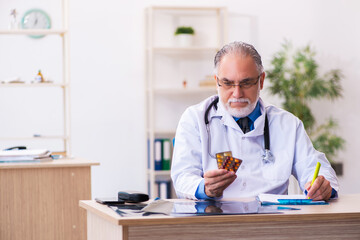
[21,9,51,38]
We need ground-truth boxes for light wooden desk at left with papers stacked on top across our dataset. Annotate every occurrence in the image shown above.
[0,159,99,240]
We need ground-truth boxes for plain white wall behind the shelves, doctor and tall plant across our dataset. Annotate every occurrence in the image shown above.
[0,0,360,197]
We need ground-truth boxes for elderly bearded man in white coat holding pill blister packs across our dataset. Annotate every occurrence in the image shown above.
[171,42,339,200]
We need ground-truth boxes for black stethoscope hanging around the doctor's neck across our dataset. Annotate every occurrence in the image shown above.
[204,96,275,164]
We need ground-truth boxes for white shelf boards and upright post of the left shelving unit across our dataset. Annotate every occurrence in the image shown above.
[0,0,71,156]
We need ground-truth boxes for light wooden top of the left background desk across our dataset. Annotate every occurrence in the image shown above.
[0,158,99,169]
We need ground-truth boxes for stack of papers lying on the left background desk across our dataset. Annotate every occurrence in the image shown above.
[0,149,53,163]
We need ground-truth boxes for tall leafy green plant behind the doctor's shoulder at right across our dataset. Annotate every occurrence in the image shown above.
[266,41,345,175]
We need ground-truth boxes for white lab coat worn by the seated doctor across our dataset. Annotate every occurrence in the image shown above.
[171,96,339,199]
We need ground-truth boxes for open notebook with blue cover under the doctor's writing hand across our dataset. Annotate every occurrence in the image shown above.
[258,193,329,205]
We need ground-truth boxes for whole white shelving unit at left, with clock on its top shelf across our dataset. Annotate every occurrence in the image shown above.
[0,0,71,155]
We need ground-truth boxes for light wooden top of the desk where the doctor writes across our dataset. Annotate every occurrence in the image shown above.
[80,194,360,226]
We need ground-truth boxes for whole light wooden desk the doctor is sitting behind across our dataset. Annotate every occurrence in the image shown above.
[80,194,360,240]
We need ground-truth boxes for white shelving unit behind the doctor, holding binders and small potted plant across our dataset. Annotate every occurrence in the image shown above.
[145,6,228,198]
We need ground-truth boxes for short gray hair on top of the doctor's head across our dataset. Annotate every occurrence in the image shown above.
[214,42,264,75]
